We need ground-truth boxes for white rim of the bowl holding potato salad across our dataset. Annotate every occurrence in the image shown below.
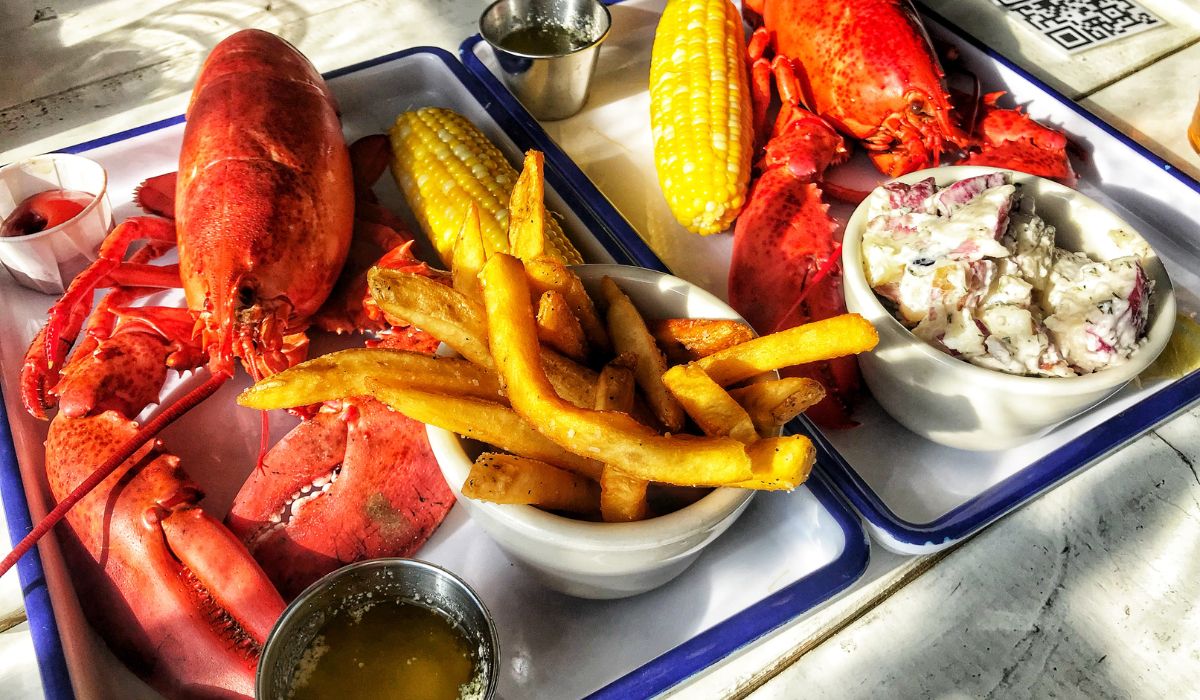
[841,166,1176,394]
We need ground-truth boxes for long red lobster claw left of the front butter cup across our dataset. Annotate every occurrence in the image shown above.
[46,411,284,698]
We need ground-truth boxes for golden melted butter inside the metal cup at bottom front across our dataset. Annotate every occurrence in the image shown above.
[289,600,474,700]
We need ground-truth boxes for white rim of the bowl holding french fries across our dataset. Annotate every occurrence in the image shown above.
[425,263,757,551]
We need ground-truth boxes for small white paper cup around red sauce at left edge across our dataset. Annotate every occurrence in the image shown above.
[0,154,113,294]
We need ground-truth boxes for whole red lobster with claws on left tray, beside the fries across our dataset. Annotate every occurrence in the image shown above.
[0,30,452,696]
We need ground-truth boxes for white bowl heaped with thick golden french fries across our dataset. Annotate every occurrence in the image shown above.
[239,151,877,598]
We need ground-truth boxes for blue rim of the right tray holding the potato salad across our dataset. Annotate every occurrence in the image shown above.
[460,0,1200,559]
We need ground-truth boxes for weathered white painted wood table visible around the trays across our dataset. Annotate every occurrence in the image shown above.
[0,0,1200,699]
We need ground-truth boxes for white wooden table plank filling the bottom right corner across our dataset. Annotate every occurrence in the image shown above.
[752,411,1200,700]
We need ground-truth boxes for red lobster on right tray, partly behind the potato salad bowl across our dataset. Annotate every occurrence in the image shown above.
[730,0,1074,427]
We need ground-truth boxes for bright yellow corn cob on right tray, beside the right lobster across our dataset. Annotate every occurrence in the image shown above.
[650,0,754,234]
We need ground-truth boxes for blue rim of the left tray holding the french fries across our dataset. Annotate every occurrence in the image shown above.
[0,45,870,700]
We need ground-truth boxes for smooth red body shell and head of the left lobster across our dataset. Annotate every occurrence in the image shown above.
[175,29,354,377]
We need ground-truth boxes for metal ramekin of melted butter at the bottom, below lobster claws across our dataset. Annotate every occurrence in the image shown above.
[256,560,499,700]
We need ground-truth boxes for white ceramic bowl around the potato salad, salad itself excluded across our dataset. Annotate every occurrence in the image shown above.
[841,166,1175,450]
